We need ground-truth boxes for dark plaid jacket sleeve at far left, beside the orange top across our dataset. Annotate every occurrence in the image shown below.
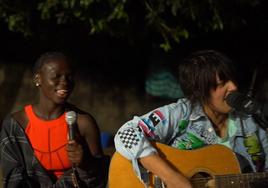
[0,116,40,187]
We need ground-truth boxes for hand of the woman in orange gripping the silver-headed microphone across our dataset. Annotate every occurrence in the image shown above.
[66,140,84,166]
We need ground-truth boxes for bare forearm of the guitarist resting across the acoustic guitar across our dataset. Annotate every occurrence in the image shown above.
[139,154,192,188]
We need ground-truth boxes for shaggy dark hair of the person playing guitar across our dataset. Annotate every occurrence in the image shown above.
[179,50,236,105]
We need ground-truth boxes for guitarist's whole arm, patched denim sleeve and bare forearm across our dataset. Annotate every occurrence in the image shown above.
[115,100,190,187]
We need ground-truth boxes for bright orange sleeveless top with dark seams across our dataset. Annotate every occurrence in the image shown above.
[25,105,71,178]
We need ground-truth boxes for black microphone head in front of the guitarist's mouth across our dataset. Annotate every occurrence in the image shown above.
[225,91,260,114]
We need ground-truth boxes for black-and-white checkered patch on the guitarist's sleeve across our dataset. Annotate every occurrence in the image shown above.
[118,128,140,149]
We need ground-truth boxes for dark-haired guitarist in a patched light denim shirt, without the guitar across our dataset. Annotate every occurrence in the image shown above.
[115,50,268,188]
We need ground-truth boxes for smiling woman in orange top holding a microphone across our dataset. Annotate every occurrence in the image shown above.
[0,52,106,188]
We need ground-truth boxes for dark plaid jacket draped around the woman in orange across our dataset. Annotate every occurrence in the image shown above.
[0,116,105,188]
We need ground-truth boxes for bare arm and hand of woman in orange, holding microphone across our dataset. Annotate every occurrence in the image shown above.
[67,113,109,186]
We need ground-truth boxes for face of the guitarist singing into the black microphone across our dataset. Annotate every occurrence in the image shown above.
[207,75,237,114]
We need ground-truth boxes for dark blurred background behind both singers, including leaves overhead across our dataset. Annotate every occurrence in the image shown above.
[0,0,268,159]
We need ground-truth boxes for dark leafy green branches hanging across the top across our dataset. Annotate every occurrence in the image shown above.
[0,0,261,51]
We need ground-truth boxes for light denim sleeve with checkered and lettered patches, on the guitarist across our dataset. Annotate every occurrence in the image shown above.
[114,100,188,181]
